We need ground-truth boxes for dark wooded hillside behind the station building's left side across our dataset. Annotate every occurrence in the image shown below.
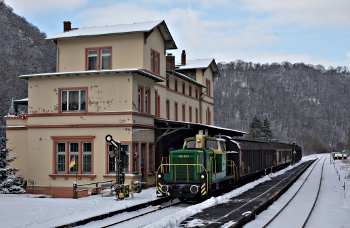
[0,2,56,134]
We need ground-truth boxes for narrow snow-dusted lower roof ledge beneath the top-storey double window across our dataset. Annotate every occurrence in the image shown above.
[18,68,164,82]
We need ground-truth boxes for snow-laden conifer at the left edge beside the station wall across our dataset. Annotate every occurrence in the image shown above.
[0,137,25,194]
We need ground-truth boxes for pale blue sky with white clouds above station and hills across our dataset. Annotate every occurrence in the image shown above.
[0,0,350,68]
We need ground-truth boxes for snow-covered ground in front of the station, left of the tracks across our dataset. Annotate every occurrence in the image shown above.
[0,188,156,228]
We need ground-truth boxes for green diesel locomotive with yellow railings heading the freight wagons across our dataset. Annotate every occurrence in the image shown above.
[156,131,237,201]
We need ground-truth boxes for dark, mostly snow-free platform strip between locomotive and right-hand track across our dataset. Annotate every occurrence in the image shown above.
[176,160,314,227]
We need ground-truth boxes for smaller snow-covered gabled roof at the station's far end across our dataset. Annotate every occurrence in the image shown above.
[175,58,221,77]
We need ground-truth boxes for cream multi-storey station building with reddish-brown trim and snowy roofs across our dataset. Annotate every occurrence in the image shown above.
[5,21,244,197]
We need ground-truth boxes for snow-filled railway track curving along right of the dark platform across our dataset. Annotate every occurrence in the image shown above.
[263,156,326,228]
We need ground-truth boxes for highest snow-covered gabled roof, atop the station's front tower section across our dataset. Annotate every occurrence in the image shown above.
[46,20,177,50]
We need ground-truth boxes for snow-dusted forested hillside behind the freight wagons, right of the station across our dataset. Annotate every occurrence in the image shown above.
[214,60,350,153]
